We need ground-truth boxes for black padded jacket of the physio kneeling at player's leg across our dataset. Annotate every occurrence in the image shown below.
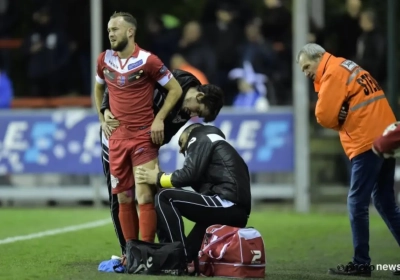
[158,125,251,214]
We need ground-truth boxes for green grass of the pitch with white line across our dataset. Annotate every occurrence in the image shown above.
[0,208,400,280]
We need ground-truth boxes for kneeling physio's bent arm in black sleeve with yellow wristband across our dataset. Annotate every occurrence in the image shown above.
[157,137,212,188]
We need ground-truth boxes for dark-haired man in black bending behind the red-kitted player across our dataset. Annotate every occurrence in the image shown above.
[100,70,224,255]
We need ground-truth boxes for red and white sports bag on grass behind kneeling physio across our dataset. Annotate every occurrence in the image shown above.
[199,225,265,278]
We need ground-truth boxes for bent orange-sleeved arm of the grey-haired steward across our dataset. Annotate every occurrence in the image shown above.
[315,74,347,130]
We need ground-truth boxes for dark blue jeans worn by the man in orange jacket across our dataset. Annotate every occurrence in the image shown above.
[347,150,400,264]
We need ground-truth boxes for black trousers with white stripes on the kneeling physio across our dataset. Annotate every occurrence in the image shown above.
[155,189,248,262]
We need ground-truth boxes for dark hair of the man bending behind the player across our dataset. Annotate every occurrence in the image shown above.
[197,84,224,122]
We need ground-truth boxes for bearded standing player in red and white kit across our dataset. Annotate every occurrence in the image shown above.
[95,12,182,247]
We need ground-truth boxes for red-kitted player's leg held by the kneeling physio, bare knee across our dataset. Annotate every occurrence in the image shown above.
[133,158,158,242]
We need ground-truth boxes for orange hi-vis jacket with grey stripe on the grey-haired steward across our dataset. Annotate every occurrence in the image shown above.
[314,52,396,159]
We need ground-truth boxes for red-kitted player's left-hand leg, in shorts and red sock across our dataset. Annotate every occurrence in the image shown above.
[109,140,138,241]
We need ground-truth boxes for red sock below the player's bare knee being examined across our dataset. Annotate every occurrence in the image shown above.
[139,203,157,242]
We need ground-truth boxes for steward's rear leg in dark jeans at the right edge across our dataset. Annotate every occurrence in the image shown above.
[372,159,400,245]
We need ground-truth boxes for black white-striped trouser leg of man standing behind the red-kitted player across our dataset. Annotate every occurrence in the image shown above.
[100,127,125,254]
